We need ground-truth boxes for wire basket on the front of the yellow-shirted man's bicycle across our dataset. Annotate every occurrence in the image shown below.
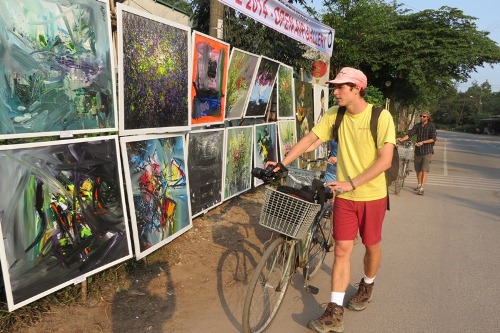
[259,187,321,239]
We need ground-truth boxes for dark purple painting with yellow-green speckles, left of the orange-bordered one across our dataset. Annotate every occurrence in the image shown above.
[116,3,191,135]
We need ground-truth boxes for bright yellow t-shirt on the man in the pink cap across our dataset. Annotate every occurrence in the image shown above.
[312,104,396,201]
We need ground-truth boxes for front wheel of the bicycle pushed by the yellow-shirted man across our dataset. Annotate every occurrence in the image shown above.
[242,237,296,333]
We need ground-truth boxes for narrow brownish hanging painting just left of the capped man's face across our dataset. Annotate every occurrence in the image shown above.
[294,79,315,169]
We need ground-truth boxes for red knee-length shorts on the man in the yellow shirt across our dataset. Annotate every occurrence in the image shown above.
[333,197,387,246]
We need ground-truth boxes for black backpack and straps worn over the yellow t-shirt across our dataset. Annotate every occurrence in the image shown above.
[333,106,399,210]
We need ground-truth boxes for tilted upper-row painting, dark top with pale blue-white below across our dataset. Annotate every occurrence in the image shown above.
[245,56,279,118]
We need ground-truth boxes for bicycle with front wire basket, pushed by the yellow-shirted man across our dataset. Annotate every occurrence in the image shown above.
[242,167,333,333]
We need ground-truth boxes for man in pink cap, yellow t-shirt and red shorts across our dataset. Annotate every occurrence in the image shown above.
[266,67,396,332]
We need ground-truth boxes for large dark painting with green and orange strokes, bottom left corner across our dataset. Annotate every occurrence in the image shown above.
[0,136,132,311]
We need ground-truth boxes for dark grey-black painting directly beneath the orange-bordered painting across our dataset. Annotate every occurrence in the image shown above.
[187,128,225,217]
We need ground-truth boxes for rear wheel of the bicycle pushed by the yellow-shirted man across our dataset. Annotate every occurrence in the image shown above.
[304,212,333,279]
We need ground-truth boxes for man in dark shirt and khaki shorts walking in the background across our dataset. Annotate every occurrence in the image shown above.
[397,111,437,195]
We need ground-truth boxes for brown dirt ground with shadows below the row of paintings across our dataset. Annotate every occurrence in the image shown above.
[9,187,271,333]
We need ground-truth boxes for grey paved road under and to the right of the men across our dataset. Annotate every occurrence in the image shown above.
[268,131,500,333]
